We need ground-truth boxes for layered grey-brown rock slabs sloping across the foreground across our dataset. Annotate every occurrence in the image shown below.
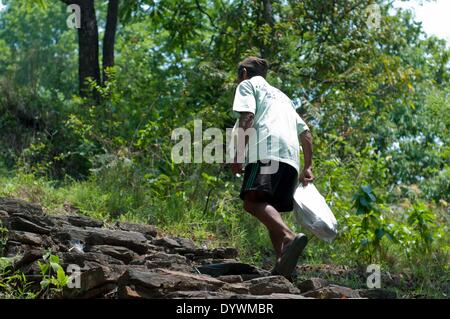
[0,198,386,299]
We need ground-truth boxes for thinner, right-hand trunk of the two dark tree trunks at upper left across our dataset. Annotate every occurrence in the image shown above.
[102,0,119,83]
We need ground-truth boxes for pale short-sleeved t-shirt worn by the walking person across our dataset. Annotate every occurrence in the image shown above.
[233,76,308,172]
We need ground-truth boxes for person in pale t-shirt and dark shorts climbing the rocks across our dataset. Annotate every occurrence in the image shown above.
[231,57,314,279]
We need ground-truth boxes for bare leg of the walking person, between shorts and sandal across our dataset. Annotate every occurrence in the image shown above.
[244,192,295,261]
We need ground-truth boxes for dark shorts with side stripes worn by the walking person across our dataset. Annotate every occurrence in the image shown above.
[239,161,298,212]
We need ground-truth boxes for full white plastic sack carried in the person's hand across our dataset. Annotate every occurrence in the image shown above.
[294,183,337,242]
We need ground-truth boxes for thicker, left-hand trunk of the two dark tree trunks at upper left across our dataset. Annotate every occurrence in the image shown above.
[76,0,101,96]
